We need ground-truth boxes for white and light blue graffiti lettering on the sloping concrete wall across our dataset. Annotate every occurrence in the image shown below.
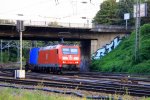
[92,36,122,59]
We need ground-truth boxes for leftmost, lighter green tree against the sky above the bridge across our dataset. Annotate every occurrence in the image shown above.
[93,0,119,24]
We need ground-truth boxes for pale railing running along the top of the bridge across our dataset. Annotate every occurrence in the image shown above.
[0,19,92,28]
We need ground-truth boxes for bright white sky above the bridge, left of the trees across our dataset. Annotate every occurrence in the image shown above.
[0,0,104,23]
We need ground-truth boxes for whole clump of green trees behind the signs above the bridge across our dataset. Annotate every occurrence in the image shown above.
[93,0,150,26]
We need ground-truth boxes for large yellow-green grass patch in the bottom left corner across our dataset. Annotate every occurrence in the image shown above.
[0,88,84,100]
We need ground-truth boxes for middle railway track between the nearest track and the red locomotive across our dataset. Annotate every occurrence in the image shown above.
[0,71,150,85]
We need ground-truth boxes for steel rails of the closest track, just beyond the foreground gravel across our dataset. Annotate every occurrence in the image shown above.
[0,77,150,96]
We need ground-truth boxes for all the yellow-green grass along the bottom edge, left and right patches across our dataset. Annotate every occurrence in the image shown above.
[0,85,150,100]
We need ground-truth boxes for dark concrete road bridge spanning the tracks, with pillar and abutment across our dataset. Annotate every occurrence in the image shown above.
[0,19,131,70]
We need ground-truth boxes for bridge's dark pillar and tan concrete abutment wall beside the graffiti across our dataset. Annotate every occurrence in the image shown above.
[80,33,125,72]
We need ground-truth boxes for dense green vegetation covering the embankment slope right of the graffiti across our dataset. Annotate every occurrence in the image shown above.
[90,24,150,74]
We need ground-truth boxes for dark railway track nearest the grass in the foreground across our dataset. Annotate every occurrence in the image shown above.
[0,77,150,96]
